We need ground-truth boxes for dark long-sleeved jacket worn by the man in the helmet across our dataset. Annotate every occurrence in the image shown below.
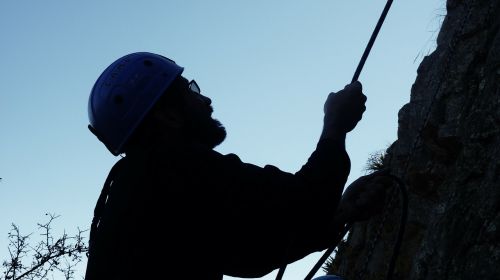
[86,140,350,280]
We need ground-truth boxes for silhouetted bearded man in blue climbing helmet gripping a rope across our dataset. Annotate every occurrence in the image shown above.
[85,52,384,280]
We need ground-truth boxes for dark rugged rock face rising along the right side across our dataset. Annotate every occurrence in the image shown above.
[330,0,500,280]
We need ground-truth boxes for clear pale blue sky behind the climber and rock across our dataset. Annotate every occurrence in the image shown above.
[0,0,445,280]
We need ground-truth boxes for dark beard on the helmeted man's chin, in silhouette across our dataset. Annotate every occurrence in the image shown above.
[184,113,226,149]
